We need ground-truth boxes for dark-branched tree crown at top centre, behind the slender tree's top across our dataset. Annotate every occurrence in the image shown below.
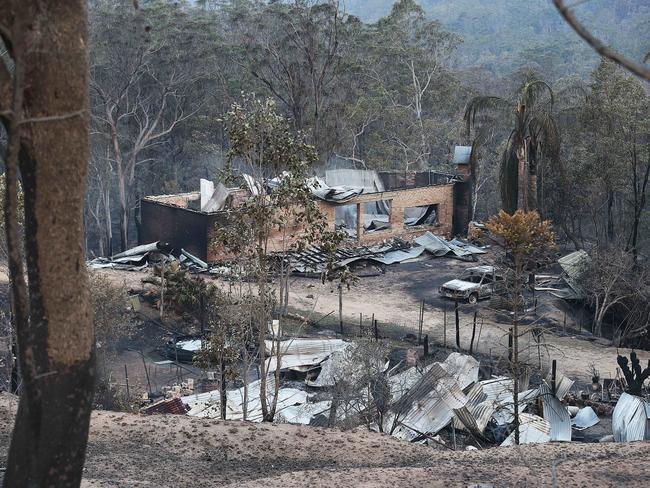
[226,0,360,159]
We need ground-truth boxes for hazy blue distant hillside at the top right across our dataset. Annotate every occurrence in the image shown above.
[345,0,650,78]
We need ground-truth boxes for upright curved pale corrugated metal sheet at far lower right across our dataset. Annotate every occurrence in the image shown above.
[612,393,650,442]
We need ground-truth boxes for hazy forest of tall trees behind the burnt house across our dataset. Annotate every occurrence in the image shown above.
[86,0,650,264]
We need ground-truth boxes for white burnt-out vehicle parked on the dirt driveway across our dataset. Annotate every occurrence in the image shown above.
[439,266,505,304]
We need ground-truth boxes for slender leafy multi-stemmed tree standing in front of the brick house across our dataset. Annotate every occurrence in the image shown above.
[213,95,342,421]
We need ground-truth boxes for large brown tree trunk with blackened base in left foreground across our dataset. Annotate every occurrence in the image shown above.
[0,0,94,488]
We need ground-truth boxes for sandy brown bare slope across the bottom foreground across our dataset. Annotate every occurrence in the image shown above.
[0,393,650,488]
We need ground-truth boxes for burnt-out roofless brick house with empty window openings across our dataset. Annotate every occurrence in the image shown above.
[139,160,471,262]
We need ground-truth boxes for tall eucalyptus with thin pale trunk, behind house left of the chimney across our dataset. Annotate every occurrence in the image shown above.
[359,0,461,169]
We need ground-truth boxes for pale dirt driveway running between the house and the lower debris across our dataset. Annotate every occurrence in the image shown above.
[95,258,650,384]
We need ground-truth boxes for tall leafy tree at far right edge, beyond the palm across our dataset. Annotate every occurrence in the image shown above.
[578,61,650,255]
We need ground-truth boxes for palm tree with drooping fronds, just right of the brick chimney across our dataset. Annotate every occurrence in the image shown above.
[463,79,560,213]
